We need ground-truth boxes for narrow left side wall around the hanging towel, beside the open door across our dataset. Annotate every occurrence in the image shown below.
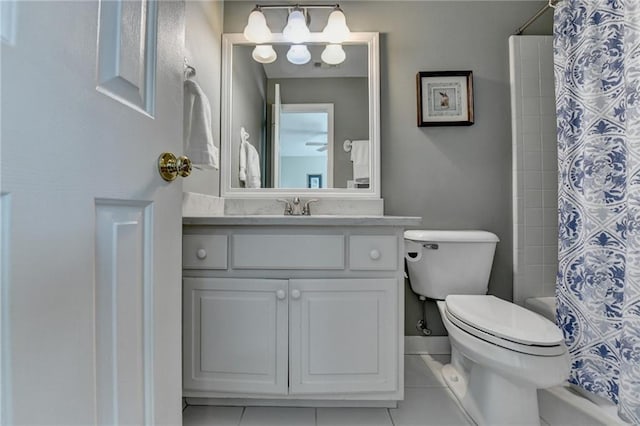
[182,1,223,195]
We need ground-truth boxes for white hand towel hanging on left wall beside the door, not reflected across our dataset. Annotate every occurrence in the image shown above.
[183,80,219,169]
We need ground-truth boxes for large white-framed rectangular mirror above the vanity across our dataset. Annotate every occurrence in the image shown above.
[220,33,380,198]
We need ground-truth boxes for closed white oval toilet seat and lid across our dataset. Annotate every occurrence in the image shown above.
[445,295,566,356]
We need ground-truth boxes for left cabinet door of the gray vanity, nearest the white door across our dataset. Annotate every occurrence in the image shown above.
[183,278,288,395]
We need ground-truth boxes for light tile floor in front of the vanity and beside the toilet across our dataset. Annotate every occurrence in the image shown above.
[183,355,473,426]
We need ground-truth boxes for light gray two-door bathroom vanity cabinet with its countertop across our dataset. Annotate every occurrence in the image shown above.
[183,216,420,406]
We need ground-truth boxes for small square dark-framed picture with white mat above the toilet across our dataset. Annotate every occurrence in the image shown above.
[416,71,473,127]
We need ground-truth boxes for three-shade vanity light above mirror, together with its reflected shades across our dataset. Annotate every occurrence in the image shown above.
[243,4,351,65]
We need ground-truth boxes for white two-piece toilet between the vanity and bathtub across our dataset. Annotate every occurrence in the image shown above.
[404,230,569,425]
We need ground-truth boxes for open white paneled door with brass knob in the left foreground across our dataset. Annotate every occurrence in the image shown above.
[0,0,184,425]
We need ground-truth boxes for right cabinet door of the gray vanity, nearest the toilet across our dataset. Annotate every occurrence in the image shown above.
[289,279,398,394]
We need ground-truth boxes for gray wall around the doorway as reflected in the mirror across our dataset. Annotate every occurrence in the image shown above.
[267,77,369,188]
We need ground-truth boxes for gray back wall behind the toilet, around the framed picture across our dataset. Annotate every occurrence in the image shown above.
[224,0,551,335]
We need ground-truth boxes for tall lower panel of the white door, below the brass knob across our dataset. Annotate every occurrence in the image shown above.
[94,200,153,425]
